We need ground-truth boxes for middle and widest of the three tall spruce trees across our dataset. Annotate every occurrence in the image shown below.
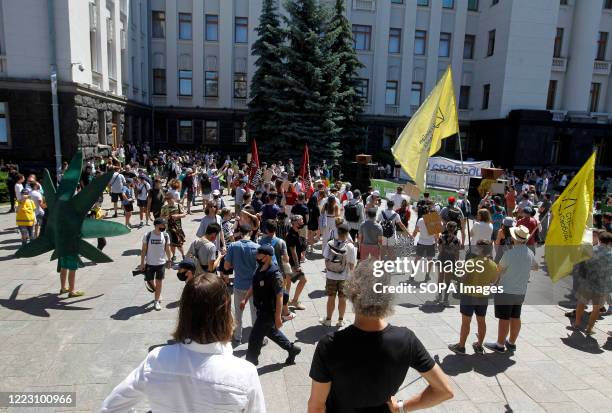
[278,0,342,160]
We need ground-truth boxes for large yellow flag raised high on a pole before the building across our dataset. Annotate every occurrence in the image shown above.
[391,66,459,191]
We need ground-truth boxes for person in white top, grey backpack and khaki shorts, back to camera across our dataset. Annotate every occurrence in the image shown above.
[319,224,357,327]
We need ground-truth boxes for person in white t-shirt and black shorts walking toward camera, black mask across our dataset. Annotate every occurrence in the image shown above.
[138,218,172,311]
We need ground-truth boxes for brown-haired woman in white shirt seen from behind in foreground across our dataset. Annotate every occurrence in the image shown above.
[101,274,266,413]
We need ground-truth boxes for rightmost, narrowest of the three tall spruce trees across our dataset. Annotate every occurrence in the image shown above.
[327,0,366,159]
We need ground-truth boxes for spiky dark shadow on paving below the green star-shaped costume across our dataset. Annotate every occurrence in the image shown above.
[0,284,104,317]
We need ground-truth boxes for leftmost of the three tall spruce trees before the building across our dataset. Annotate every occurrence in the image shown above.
[247,0,291,159]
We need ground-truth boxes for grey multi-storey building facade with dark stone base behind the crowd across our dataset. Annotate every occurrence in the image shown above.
[0,0,612,168]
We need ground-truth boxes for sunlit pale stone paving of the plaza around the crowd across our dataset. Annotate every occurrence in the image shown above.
[0,200,612,413]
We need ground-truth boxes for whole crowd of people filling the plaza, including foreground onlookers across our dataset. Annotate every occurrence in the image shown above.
[2,146,612,412]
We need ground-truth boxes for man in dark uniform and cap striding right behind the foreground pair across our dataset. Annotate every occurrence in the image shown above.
[240,245,302,365]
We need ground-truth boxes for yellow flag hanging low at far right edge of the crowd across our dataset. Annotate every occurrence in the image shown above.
[544,152,597,282]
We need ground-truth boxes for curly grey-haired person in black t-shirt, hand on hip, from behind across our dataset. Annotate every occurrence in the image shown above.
[308,261,453,413]
